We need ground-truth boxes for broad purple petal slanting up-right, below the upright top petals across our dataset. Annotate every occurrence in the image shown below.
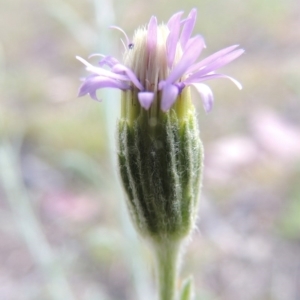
[166,36,204,83]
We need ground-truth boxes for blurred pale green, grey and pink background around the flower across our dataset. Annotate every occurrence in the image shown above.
[0,0,300,300]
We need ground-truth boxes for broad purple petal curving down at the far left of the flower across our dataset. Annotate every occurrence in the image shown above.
[78,76,130,97]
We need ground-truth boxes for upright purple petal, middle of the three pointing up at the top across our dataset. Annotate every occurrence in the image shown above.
[166,12,183,68]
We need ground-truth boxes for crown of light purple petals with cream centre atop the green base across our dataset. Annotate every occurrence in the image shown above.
[77,9,244,112]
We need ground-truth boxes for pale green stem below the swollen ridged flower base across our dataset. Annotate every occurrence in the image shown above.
[155,241,180,300]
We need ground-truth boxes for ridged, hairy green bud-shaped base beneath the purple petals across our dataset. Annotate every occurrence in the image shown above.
[118,89,203,241]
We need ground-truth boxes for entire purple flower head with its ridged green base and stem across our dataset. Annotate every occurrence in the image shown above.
[77,9,244,300]
